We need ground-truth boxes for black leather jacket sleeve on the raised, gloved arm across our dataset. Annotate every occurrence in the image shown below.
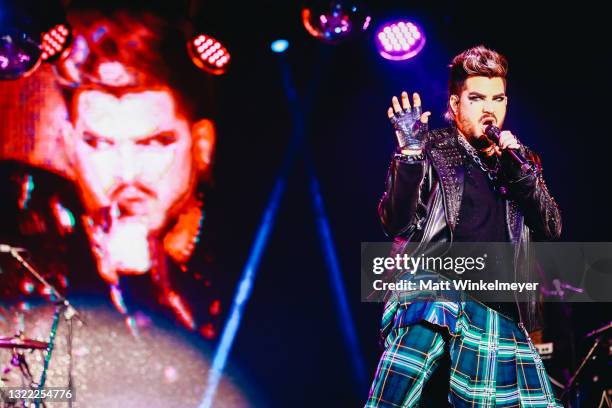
[378,156,429,237]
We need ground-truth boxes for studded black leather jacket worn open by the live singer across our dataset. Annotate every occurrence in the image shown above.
[378,127,561,331]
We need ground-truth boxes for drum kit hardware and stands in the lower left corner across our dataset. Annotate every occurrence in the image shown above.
[0,244,83,408]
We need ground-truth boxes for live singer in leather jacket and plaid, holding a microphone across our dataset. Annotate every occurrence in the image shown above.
[366,46,561,407]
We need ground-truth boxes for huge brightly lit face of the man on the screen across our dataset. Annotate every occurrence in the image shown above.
[68,90,193,231]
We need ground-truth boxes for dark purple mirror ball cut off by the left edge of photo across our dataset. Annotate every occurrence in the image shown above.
[0,30,41,80]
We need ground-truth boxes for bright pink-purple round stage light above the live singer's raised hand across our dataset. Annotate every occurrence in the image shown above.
[375,20,425,61]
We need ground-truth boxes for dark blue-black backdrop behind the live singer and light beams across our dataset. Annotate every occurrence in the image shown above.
[2,0,612,407]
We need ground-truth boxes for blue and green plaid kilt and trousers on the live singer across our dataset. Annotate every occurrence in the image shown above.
[365,296,561,408]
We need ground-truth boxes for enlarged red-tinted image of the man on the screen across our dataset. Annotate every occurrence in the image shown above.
[0,9,220,338]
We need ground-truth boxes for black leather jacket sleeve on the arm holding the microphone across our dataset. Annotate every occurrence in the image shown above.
[501,148,562,240]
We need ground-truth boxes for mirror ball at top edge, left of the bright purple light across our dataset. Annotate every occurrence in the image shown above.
[302,0,371,44]
